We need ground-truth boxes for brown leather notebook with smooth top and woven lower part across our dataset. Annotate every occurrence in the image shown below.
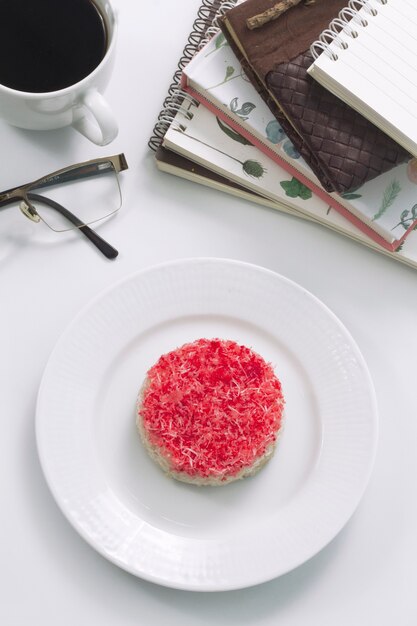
[220,0,410,193]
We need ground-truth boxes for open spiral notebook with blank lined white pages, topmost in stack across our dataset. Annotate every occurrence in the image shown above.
[308,0,417,156]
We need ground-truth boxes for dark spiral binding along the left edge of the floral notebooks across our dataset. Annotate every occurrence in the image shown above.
[148,0,236,151]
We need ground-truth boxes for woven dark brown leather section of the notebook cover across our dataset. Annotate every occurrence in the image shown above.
[266,51,410,193]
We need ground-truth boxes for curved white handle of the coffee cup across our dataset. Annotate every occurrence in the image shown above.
[72,89,118,146]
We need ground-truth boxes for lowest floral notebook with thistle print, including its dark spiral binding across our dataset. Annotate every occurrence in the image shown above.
[149,0,417,268]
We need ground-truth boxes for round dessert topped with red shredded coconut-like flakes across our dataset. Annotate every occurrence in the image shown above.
[137,339,284,485]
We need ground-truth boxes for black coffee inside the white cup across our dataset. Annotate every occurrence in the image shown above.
[0,0,107,93]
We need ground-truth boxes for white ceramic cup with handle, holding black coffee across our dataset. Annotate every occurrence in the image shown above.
[0,0,118,146]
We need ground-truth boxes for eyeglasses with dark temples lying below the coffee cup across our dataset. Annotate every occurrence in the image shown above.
[0,154,128,259]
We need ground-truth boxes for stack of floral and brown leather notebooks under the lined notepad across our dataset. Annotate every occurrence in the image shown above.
[150,0,417,267]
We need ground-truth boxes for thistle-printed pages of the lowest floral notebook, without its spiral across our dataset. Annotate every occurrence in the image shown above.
[156,102,417,269]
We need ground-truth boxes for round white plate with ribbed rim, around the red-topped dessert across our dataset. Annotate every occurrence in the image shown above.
[37,259,377,591]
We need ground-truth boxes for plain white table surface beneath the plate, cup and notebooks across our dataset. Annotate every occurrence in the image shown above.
[0,0,417,626]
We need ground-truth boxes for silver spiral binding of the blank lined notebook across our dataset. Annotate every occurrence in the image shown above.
[310,0,390,61]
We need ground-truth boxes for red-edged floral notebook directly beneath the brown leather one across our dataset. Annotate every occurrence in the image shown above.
[182,32,417,250]
